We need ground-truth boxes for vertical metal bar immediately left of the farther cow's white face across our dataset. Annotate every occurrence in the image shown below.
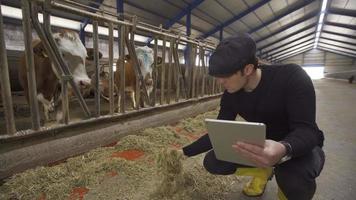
[115,25,126,113]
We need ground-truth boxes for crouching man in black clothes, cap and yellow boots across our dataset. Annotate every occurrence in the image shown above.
[183,33,325,200]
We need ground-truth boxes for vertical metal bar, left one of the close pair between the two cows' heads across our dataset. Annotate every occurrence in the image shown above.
[109,22,114,115]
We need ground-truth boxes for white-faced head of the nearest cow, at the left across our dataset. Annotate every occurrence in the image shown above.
[53,30,91,90]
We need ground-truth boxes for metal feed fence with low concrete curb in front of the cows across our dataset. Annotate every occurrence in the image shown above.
[0,1,222,184]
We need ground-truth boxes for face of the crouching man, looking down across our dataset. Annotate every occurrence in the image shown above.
[216,71,247,93]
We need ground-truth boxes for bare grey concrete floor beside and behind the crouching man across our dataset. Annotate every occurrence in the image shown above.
[229,79,356,200]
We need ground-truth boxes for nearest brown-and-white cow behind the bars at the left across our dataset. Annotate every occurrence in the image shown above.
[19,30,91,122]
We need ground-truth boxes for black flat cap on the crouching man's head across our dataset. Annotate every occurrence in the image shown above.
[209,33,256,77]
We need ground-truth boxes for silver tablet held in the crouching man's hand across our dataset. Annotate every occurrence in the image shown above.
[205,119,266,166]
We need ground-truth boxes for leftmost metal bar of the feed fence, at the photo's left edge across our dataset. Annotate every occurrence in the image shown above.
[0,0,16,135]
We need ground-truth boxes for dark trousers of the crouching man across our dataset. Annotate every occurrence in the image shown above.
[204,147,325,200]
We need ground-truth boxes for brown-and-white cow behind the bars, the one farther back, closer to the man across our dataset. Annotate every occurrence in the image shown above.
[114,46,162,108]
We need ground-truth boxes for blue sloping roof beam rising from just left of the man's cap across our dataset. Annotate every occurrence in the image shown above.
[201,0,271,38]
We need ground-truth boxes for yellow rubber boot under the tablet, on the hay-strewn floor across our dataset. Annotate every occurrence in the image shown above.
[236,168,272,197]
